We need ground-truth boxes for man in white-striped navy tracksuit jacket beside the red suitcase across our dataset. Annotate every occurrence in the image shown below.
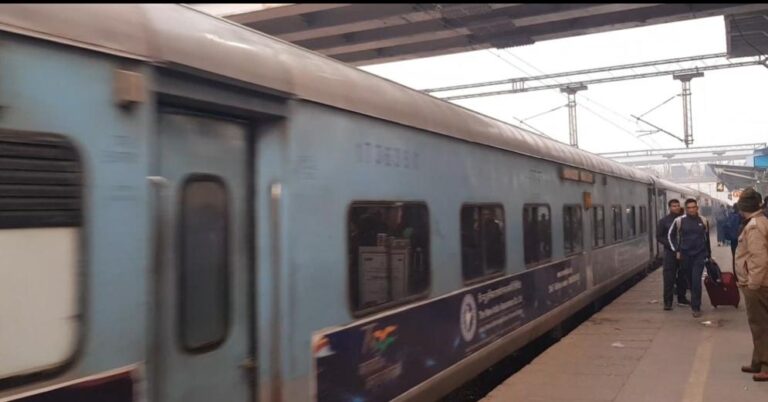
[667,198,712,317]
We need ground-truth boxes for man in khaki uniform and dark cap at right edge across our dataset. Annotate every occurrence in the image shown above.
[736,188,768,381]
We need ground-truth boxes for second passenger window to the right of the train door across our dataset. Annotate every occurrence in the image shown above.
[461,204,506,282]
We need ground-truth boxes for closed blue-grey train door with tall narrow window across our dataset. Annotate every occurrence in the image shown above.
[152,110,255,402]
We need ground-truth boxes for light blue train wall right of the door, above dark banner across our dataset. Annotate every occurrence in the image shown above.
[281,103,650,400]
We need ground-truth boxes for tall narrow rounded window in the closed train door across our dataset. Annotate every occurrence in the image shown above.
[179,175,229,350]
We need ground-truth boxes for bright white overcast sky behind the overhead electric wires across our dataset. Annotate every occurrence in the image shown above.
[362,17,768,153]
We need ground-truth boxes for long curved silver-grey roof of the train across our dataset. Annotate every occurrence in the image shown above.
[0,4,653,183]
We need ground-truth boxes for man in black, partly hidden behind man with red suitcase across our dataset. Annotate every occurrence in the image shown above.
[656,199,691,311]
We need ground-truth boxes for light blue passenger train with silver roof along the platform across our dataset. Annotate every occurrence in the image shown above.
[0,4,719,402]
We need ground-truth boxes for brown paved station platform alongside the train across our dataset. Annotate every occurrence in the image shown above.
[482,240,768,402]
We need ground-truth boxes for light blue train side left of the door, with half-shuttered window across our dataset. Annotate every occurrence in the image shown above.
[0,33,152,397]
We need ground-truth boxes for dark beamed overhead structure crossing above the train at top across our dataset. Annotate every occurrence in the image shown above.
[194,3,768,65]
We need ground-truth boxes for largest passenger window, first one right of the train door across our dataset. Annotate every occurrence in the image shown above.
[348,202,430,313]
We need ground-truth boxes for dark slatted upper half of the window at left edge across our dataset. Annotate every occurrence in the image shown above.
[0,129,83,229]
